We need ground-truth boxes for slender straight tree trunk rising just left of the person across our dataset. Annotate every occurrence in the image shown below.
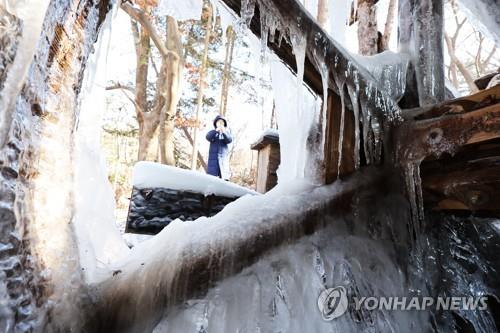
[191,4,212,170]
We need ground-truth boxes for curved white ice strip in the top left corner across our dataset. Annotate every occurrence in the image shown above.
[0,0,49,147]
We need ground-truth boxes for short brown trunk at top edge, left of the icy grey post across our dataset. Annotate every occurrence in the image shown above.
[358,0,379,55]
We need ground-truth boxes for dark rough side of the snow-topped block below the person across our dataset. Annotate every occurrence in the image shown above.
[125,187,238,235]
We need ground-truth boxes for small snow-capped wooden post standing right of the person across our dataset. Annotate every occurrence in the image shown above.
[251,133,280,193]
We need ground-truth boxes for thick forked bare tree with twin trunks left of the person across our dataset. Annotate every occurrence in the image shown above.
[121,2,184,165]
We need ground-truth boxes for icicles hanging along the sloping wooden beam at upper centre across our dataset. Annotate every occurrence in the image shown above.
[241,0,401,175]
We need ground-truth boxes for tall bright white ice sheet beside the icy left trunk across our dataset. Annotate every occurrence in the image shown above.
[73,9,129,283]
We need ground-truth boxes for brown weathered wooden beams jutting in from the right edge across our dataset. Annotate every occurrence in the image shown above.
[394,86,500,215]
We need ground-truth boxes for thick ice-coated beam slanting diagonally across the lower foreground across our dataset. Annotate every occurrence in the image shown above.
[84,168,383,333]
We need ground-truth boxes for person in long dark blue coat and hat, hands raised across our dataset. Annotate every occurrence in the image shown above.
[207,116,233,180]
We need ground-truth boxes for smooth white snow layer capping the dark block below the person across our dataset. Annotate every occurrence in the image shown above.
[132,161,258,197]
